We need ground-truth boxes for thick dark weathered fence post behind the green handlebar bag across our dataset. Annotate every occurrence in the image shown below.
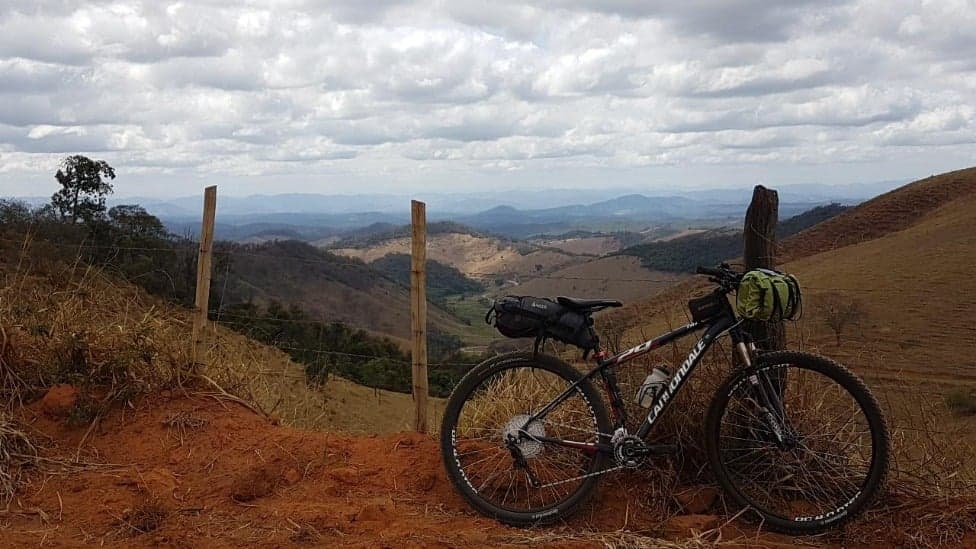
[742,185,786,351]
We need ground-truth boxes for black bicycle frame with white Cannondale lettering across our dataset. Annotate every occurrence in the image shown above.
[525,307,743,452]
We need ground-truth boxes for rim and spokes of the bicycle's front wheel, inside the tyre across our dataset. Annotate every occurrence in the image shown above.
[717,364,879,524]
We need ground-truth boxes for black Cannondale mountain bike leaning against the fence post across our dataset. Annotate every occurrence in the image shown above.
[441,264,890,534]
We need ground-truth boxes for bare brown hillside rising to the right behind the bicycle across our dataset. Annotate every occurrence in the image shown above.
[612,168,976,392]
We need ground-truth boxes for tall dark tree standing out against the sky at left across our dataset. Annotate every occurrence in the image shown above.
[51,154,115,224]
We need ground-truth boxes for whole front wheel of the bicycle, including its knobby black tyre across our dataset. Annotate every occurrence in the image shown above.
[706,352,889,534]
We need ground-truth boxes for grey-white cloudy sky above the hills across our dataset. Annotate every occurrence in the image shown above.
[0,0,976,196]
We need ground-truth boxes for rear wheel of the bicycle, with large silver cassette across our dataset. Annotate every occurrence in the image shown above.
[441,353,611,526]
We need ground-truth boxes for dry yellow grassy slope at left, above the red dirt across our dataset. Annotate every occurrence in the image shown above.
[0,234,442,432]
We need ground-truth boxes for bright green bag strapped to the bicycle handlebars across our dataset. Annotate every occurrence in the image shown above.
[735,269,801,322]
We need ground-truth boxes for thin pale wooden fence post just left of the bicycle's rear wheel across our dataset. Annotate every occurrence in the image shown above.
[410,200,427,433]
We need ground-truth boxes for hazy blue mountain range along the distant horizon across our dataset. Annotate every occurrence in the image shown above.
[7,181,901,240]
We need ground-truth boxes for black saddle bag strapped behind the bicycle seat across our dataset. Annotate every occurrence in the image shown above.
[485,296,599,350]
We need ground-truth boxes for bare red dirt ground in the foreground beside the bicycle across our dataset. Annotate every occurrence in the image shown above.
[0,395,816,547]
